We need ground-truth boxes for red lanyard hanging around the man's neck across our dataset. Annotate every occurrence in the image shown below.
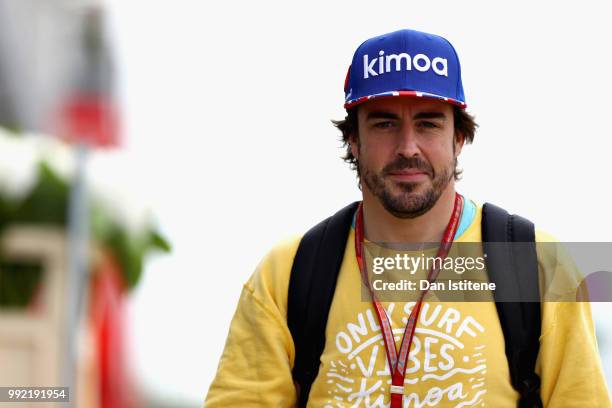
[355,193,463,408]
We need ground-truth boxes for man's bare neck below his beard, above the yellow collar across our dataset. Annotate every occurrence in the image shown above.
[363,181,455,243]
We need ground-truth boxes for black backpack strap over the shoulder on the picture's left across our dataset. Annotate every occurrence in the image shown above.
[287,202,359,407]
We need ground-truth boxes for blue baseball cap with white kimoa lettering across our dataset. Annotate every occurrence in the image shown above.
[344,30,467,109]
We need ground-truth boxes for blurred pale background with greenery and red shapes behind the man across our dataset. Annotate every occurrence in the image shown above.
[0,0,612,408]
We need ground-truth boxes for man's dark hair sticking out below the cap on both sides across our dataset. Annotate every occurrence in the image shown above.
[332,105,478,180]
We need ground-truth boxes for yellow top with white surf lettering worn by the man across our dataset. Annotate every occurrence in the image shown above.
[204,208,612,408]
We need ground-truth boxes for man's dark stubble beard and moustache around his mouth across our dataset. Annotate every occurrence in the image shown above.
[358,156,456,219]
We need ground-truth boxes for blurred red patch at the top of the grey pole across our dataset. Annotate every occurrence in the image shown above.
[58,94,119,147]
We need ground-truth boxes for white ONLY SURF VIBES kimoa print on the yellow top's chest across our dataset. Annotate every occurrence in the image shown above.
[321,302,487,408]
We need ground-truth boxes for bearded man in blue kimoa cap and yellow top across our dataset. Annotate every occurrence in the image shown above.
[205,30,611,408]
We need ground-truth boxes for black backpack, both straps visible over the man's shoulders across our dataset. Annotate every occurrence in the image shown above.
[287,202,542,408]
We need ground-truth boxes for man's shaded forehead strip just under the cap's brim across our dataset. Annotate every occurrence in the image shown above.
[359,97,452,115]
